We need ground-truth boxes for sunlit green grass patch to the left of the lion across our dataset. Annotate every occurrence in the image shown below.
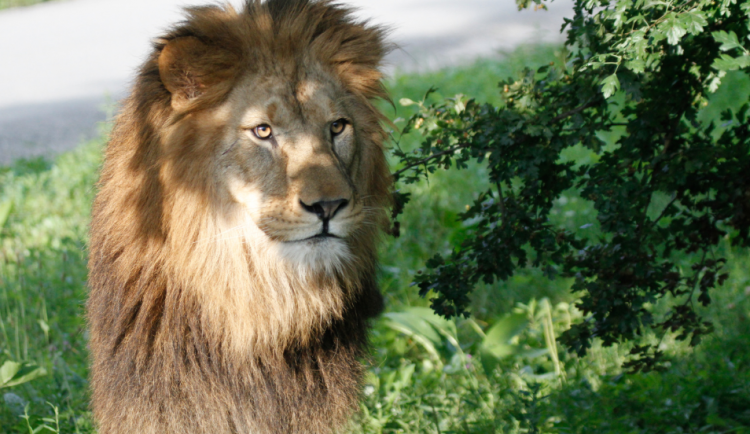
[0,139,104,433]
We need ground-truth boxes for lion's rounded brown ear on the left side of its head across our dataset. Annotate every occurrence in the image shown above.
[159,36,239,111]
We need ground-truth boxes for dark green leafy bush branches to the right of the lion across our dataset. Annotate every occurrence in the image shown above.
[394,0,750,371]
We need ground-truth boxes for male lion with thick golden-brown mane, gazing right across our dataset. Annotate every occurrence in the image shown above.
[88,0,391,434]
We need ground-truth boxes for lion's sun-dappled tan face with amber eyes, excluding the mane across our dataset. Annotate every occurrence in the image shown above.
[194,68,382,269]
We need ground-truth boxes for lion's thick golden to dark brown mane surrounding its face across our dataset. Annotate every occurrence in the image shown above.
[88,0,390,434]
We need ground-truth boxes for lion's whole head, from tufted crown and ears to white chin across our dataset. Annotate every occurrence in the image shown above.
[147,10,390,282]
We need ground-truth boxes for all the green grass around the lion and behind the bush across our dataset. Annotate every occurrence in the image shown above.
[0,46,750,434]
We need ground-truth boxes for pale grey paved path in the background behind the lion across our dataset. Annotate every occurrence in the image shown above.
[0,0,572,164]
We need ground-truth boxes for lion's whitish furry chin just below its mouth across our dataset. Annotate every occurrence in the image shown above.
[275,236,353,274]
